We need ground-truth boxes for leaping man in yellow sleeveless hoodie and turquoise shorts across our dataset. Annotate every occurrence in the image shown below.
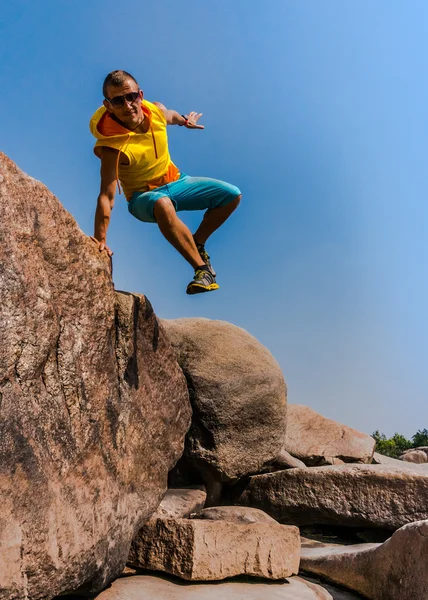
[90,71,241,294]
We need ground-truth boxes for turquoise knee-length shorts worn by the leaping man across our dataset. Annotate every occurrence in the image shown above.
[128,173,241,223]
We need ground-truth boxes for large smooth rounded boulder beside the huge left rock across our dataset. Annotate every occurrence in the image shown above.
[162,319,286,482]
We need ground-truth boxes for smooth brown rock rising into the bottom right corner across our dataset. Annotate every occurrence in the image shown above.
[301,521,428,600]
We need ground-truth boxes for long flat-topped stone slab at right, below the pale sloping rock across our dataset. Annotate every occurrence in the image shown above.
[235,463,428,529]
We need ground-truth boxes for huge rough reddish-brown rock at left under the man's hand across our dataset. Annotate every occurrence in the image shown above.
[0,154,190,600]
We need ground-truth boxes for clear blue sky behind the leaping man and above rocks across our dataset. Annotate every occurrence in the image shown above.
[0,0,428,436]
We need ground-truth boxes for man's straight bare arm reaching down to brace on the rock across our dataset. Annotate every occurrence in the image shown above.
[92,148,118,256]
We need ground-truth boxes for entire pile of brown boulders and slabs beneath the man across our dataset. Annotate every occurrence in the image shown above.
[0,154,428,600]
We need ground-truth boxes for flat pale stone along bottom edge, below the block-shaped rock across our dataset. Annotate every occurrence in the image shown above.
[96,575,342,600]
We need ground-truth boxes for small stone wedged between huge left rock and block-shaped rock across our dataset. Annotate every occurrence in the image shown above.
[151,486,207,519]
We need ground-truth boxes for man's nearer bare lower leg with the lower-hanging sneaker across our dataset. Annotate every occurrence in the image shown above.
[153,196,219,294]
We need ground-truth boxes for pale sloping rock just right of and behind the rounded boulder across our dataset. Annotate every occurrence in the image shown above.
[284,404,376,466]
